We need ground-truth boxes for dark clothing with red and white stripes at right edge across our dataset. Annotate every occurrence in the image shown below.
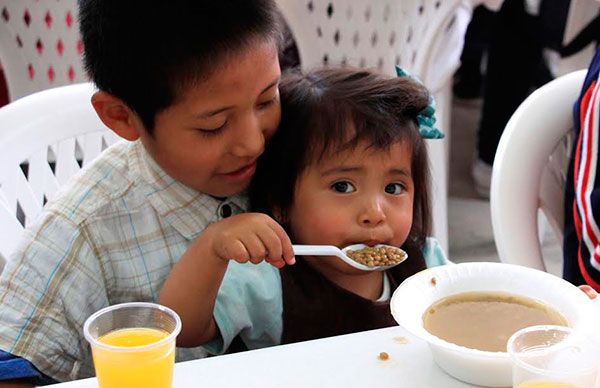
[563,45,600,291]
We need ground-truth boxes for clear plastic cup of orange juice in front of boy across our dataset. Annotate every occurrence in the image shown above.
[83,302,181,388]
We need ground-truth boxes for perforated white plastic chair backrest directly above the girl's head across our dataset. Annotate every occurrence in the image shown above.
[277,0,471,89]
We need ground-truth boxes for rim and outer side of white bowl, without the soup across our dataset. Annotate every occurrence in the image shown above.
[391,263,598,387]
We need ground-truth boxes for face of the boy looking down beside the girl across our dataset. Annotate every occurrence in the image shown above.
[140,41,281,197]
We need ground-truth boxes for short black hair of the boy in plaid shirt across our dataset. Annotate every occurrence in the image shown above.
[79,0,281,132]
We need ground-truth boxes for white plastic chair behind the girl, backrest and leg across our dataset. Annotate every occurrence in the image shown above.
[277,0,472,252]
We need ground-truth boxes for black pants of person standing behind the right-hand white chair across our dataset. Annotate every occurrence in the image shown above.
[477,0,569,165]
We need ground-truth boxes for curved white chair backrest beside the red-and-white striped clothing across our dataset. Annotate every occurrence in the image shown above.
[490,70,586,270]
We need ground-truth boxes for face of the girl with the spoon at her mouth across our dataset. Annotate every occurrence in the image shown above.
[288,142,414,273]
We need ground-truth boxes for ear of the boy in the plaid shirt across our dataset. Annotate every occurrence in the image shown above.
[92,91,143,141]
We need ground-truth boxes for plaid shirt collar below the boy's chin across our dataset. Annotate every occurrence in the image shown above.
[130,140,248,240]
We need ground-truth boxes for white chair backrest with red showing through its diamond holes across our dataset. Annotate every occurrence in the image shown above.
[0,0,87,101]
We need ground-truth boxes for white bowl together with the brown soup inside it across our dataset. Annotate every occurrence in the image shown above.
[391,263,597,387]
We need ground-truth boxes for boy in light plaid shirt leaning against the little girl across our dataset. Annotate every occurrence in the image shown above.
[0,0,291,387]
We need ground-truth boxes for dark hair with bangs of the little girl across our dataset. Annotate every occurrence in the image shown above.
[249,68,431,254]
